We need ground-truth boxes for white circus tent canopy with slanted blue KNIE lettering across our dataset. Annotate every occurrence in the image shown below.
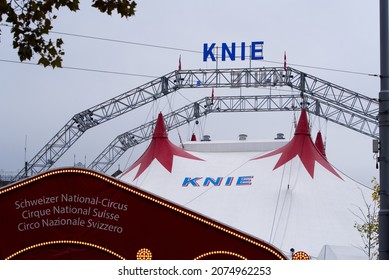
[120,111,371,259]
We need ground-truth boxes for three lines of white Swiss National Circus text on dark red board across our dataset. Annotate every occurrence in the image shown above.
[15,194,128,233]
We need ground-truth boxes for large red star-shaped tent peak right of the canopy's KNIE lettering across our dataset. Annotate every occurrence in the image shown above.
[254,109,342,179]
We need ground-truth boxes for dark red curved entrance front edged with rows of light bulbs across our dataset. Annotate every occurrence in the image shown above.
[0,168,285,260]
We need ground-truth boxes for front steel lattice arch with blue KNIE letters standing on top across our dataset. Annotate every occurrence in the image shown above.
[14,67,378,183]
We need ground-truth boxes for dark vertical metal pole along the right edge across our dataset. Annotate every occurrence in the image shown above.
[378,0,389,260]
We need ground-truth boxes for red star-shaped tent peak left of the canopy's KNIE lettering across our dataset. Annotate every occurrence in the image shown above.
[121,113,202,180]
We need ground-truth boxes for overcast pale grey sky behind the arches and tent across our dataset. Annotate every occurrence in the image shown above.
[0,0,379,186]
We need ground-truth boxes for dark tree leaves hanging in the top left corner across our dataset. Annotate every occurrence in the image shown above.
[0,0,136,68]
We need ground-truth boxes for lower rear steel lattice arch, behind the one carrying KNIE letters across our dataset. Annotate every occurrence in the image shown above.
[88,95,378,173]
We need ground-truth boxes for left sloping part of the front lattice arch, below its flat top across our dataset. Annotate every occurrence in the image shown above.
[14,71,177,181]
